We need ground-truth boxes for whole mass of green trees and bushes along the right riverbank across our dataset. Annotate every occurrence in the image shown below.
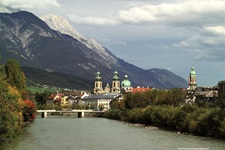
[105,88,225,138]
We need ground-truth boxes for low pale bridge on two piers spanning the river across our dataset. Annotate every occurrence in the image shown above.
[37,110,104,118]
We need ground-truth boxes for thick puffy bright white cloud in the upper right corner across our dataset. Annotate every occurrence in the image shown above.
[118,0,225,25]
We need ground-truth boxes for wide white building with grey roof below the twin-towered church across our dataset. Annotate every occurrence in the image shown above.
[81,93,122,110]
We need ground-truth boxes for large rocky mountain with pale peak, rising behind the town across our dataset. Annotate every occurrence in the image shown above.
[0,11,187,88]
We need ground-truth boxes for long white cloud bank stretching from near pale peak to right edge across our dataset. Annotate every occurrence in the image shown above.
[58,0,225,26]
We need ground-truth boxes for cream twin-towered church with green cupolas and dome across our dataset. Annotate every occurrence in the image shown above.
[94,71,132,94]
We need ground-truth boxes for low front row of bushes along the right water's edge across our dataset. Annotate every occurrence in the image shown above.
[104,104,225,139]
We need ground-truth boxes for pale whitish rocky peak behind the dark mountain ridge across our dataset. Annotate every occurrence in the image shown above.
[40,14,116,62]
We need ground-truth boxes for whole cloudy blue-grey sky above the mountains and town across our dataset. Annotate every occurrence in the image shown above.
[0,0,225,86]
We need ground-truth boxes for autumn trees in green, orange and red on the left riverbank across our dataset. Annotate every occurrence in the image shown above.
[0,59,36,145]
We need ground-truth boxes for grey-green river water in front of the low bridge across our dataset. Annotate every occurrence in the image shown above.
[3,117,225,150]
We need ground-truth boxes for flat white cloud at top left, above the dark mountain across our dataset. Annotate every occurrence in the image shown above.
[0,0,60,9]
